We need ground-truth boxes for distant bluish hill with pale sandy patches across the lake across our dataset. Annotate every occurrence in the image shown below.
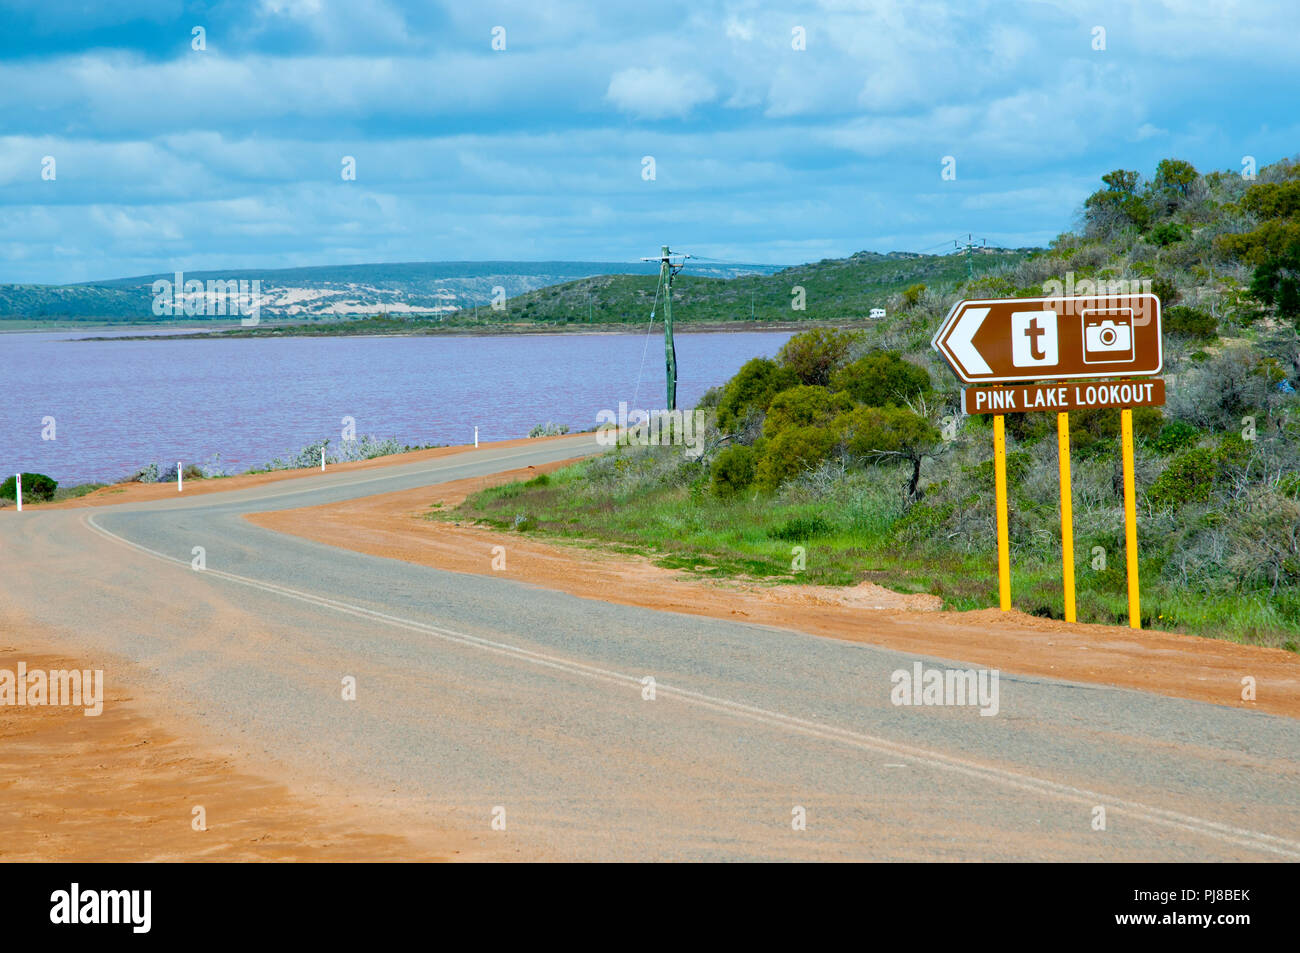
[0,261,776,322]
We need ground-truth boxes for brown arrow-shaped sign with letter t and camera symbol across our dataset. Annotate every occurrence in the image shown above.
[931,294,1164,384]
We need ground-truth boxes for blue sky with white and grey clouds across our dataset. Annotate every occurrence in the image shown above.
[0,0,1300,282]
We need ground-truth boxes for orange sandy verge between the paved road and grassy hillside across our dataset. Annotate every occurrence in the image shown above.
[247,462,1300,718]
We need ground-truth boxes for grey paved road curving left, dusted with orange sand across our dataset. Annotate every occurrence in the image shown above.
[0,436,1300,861]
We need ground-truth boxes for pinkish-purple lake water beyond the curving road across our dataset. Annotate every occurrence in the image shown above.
[0,332,790,485]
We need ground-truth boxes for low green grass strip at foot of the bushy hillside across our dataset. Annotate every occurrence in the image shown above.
[444,447,1300,651]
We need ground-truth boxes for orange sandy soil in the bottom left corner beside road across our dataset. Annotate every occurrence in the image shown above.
[0,614,488,862]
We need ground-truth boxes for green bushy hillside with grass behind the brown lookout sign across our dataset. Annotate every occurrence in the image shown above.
[441,156,1300,651]
